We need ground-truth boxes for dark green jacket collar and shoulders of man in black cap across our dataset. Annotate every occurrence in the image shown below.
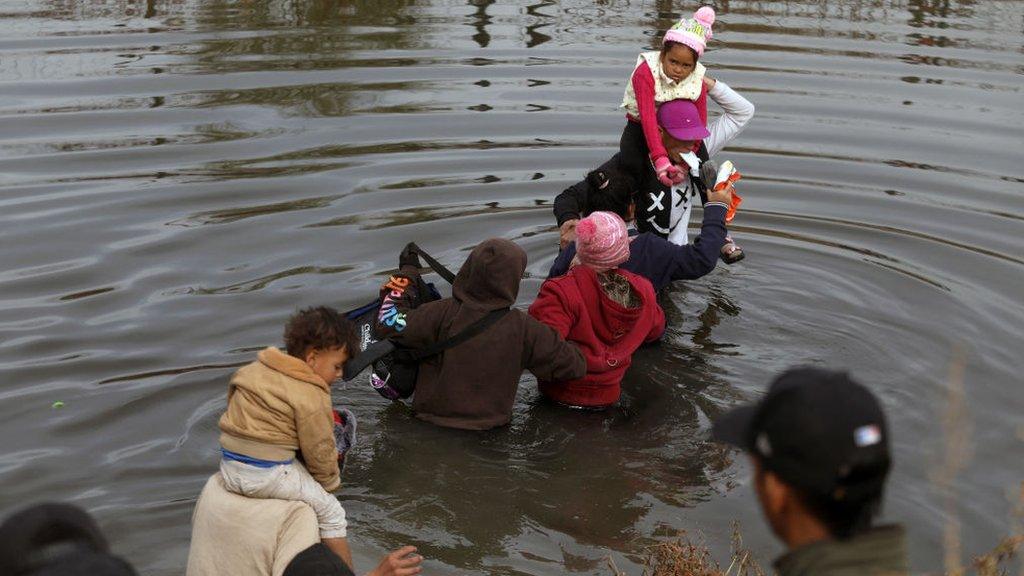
[775,526,909,576]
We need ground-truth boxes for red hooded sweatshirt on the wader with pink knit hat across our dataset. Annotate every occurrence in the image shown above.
[529,265,665,407]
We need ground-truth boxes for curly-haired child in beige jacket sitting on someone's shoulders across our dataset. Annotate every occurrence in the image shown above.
[219,306,358,567]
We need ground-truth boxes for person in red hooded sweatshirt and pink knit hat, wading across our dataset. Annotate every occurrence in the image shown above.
[529,208,665,409]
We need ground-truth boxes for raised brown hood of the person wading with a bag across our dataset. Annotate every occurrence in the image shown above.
[452,238,526,311]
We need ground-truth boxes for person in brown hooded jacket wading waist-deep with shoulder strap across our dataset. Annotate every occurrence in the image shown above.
[389,238,587,429]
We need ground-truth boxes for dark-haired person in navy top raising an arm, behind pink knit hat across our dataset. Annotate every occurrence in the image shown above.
[548,166,732,291]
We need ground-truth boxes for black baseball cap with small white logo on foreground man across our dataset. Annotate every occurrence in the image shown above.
[712,367,891,502]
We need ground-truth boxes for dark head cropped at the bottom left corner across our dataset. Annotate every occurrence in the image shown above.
[0,503,136,576]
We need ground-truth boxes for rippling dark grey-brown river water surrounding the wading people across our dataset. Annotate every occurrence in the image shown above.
[0,0,1024,574]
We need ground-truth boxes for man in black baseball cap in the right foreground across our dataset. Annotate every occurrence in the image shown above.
[712,367,908,576]
